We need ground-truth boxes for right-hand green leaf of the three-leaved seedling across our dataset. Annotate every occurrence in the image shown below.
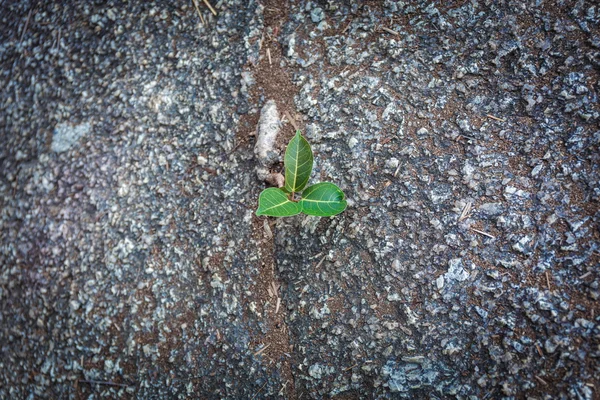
[300,182,347,217]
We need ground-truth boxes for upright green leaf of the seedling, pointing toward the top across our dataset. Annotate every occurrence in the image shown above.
[284,131,313,192]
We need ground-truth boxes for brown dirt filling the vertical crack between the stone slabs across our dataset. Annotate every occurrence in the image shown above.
[232,0,302,399]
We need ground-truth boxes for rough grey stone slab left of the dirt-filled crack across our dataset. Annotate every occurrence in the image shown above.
[0,1,281,399]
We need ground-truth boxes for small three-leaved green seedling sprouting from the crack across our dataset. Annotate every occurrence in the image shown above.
[256,131,347,217]
